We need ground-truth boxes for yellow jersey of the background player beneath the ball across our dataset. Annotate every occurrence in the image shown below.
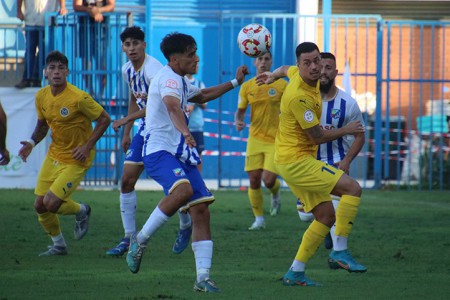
[238,78,287,143]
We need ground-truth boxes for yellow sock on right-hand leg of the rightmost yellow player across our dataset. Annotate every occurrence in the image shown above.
[334,195,361,237]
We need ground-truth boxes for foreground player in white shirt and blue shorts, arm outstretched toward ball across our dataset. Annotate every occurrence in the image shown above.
[127,32,248,292]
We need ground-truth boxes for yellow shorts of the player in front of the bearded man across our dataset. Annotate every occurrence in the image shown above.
[276,156,344,212]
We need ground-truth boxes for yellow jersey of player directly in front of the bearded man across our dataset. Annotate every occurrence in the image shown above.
[275,66,322,164]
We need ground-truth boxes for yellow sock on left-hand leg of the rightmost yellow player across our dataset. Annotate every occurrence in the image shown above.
[295,220,330,263]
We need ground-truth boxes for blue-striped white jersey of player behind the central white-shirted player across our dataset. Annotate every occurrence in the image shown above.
[122,54,163,136]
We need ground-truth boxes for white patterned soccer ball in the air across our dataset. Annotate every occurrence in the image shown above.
[237,23,272,57]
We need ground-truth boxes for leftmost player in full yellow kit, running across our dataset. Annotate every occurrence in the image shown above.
[19,51,110,256]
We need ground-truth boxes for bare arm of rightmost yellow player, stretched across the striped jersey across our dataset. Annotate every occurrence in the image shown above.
[305,121,365,145]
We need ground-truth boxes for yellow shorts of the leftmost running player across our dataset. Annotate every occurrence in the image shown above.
[34,155,88,200]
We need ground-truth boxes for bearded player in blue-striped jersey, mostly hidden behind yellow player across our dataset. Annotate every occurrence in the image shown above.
[297,52,364,268]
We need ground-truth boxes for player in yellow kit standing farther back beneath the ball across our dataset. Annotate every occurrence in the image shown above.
[235,52,287,230]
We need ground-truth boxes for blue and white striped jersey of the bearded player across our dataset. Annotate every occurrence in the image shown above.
[317,88,364,165]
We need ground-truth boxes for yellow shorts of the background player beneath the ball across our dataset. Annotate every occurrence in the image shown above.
[244,137,277,174]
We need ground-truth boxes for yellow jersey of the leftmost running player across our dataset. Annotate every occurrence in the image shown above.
[36,83,103,168]
